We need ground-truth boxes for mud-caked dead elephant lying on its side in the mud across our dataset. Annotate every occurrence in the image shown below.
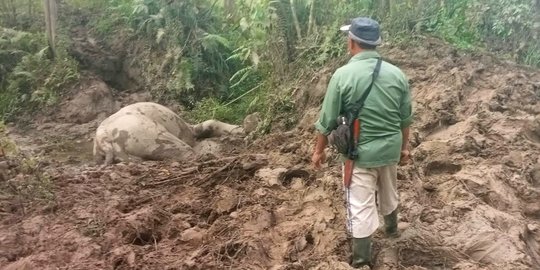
[94,102,244,164]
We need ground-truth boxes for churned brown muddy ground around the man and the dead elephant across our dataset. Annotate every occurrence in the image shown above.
[0,37,540,269]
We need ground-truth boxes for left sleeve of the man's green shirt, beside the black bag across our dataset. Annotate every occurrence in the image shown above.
[315,72,342,135]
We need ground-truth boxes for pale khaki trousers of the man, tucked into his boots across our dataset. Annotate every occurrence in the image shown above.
[345,165,399,238]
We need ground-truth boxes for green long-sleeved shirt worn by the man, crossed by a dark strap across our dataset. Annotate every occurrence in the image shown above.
[315,51,413,168]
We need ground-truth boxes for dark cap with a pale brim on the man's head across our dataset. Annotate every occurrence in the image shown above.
[340,17,382,46]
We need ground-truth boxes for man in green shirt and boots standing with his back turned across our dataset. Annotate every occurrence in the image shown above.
[312,17,413,267]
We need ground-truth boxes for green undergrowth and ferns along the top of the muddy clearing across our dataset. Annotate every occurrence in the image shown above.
[0,0,540,123]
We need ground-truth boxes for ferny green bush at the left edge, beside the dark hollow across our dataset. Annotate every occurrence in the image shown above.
[0,29,79,120]
